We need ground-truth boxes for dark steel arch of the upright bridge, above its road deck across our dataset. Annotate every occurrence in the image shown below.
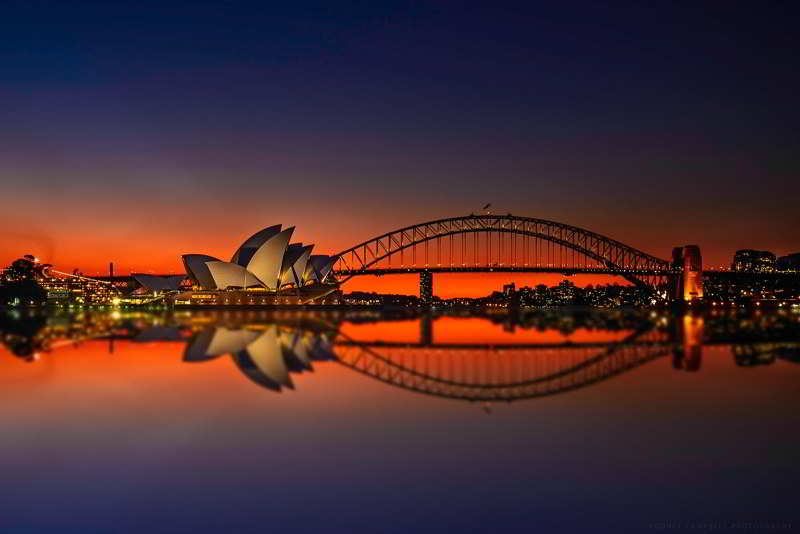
[333,214,679,288]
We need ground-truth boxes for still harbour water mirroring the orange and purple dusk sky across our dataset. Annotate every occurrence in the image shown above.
[0,310,800,532]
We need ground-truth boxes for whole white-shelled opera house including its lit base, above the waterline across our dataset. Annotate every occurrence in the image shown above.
[175,225,339,306]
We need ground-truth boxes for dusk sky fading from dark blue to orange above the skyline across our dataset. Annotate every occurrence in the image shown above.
[0,1,800,296]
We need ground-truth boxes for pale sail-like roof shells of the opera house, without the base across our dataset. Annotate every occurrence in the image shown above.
[182,225,336,292]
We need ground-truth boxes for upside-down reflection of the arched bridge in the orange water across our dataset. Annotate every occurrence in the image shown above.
[334,330,672,402]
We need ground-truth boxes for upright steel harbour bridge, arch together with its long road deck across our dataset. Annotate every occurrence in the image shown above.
[333,214,702,297]
